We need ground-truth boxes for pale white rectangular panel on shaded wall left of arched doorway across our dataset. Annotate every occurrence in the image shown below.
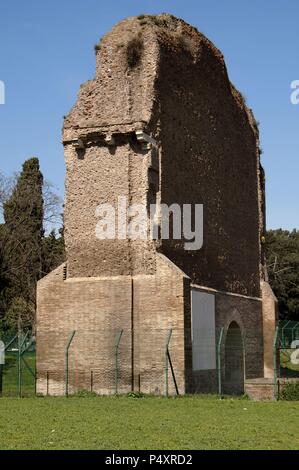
[191,289,216,370]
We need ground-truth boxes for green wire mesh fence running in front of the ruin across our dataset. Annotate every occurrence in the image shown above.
[0,322,299,397]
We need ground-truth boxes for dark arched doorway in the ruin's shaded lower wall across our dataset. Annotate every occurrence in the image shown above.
[223,321,244,395]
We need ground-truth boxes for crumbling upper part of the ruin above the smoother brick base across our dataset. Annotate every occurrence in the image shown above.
[64,15,262,296]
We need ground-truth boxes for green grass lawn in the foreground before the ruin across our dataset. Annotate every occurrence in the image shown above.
[0,396,299,450]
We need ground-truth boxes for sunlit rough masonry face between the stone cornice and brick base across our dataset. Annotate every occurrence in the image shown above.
[65,138,155,278]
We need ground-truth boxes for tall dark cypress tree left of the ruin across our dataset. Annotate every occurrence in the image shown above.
[3,158,44,324]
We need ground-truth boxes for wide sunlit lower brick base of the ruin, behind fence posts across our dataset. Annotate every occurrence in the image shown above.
[37,257,191,395]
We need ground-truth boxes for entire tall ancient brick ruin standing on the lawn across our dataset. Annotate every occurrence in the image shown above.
[37,15,276,396]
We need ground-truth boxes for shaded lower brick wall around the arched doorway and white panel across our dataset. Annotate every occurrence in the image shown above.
[192,285,264,393]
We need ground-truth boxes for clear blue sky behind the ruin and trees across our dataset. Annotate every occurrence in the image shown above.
[0,0,299,229]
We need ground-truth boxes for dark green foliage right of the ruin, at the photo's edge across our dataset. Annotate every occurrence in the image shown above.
[265,229,299,320]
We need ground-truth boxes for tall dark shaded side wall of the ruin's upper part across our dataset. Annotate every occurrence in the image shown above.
[157,35,261,297]
